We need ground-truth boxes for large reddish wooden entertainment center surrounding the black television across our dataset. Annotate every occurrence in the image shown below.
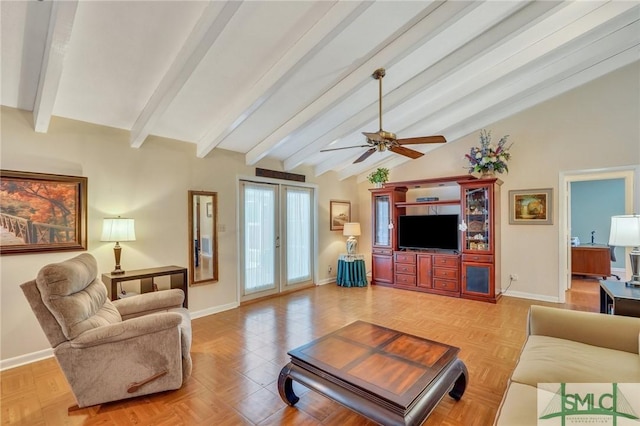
[370,175,502,303]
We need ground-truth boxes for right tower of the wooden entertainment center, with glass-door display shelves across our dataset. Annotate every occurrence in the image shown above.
[460,178,502,303]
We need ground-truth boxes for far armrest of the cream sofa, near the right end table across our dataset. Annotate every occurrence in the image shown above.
[527,305,640,354]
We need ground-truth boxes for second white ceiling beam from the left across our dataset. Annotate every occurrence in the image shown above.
[129,1,242,148]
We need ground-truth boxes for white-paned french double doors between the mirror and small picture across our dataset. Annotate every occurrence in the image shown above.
[239,181,315,300]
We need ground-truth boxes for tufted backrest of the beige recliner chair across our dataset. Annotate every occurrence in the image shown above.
[36,253,122,340]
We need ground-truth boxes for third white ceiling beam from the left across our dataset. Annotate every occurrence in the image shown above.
[197,2,373,161]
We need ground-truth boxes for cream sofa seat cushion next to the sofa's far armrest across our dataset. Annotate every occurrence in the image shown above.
[511,336,640,387]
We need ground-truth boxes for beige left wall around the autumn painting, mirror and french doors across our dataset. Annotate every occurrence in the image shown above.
[0,108,359,365]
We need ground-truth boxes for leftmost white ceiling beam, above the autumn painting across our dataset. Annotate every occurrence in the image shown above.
[33,1,78,133]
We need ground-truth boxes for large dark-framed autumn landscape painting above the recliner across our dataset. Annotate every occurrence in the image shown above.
[0,170,87,255]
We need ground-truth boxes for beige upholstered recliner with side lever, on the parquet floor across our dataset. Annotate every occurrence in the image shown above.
[21,253,191,410]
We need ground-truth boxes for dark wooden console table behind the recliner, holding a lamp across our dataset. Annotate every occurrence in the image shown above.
[102,266,188,308]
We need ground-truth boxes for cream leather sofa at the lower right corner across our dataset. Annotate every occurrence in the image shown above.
[494,305,640,426]
